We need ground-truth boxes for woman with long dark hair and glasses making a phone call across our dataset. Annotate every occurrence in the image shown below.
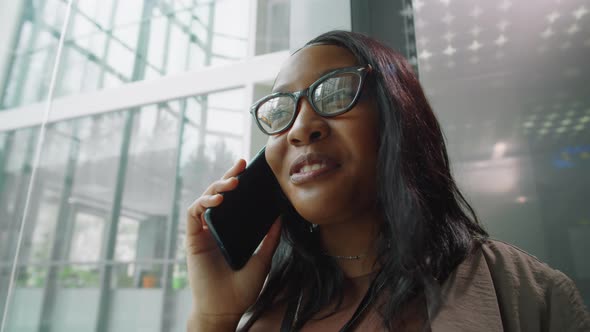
[187,31,590,331]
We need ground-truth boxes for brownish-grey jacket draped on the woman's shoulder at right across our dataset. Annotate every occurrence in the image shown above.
[431,240,590,332]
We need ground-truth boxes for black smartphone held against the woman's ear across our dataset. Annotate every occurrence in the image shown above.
[205,148,288,270]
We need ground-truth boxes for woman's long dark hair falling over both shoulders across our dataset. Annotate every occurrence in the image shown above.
[242,31,487,330]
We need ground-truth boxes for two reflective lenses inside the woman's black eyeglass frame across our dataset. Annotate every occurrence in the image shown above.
[256,73,361,133]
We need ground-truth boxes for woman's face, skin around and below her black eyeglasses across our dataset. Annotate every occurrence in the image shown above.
[266,45,378,224]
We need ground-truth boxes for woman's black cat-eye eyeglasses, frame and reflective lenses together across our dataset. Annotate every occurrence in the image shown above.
[250,66,372,135]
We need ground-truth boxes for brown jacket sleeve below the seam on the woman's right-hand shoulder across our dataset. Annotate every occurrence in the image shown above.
[481,240,590,331]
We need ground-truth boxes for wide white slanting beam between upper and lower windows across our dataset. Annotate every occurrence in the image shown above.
[0,51,289,132]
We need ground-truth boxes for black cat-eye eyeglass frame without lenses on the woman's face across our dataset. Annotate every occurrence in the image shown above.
[250,65,373,136]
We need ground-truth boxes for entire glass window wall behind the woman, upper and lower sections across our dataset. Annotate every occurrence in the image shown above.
[0,0,289,331]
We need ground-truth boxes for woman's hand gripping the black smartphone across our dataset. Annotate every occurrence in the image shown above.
[186,159,280,330]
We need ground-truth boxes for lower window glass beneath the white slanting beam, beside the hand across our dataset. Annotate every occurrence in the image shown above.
[0,88,249,331]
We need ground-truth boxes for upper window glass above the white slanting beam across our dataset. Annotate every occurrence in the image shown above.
[0,0,256,109]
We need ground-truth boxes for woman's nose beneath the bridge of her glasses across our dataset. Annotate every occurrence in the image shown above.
[287,98,330,146]
